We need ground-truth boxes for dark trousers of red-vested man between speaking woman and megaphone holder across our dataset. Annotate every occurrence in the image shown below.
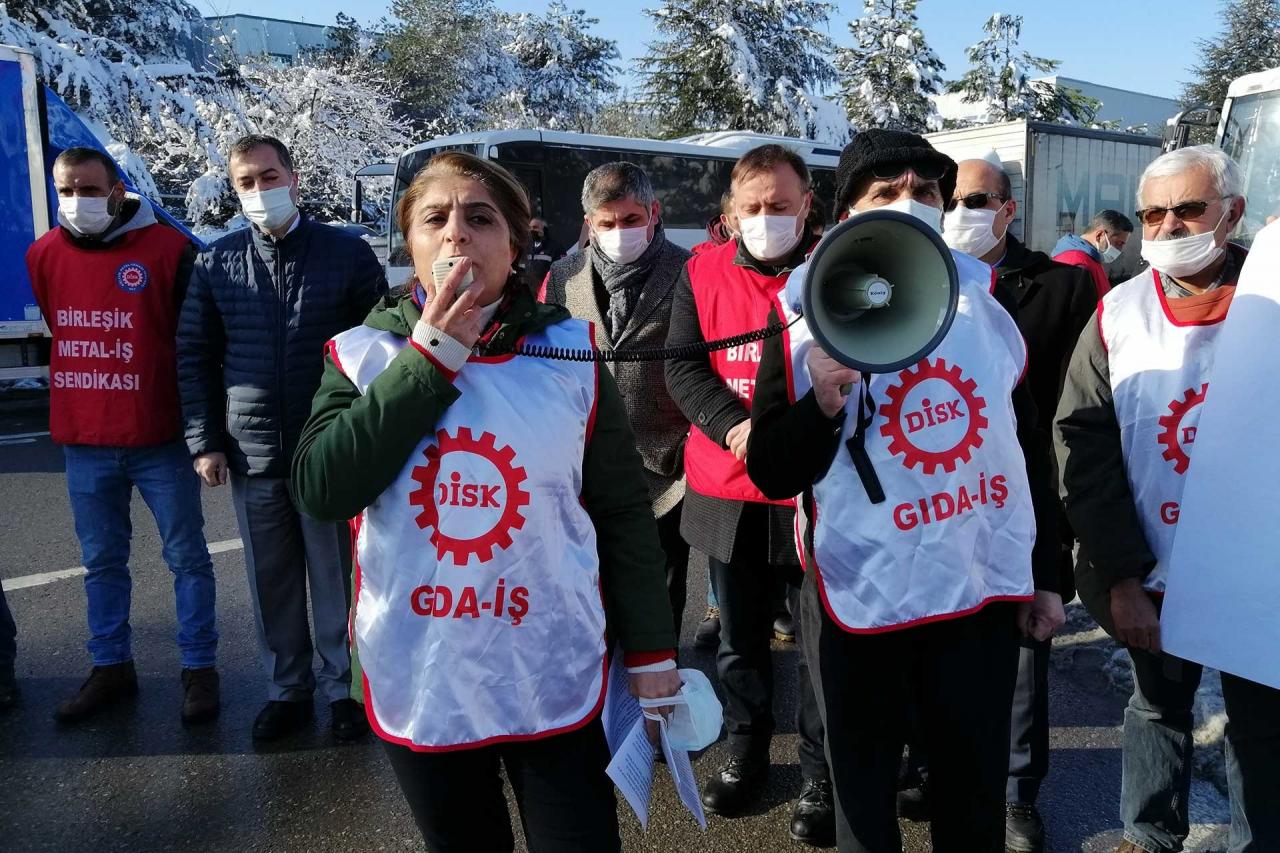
[708,507,828,779]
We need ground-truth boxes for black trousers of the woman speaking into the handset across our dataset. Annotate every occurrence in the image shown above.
[383,719,622,853]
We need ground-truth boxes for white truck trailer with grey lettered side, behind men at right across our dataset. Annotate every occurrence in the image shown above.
[927,120,1160,280]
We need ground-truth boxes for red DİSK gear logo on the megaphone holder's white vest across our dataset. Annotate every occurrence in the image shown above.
[881,359,988,475]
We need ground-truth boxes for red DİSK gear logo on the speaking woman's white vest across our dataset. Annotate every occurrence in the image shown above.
[408,427,529,566]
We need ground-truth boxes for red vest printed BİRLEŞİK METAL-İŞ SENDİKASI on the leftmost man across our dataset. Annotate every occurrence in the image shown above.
[27,224,187,447]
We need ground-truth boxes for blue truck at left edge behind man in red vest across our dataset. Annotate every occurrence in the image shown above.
[0,45,200,380]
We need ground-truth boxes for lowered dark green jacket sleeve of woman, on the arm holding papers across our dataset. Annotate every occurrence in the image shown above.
[582,369,676,652]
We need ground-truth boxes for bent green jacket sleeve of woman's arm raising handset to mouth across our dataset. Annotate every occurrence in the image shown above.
[293,346,458,521]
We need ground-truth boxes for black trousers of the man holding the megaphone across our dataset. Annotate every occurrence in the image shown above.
[800,575,1018,853]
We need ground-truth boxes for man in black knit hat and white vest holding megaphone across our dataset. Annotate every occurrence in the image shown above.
[746,131,1064,853]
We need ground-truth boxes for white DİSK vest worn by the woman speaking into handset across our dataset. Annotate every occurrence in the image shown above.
[333,320,605,751]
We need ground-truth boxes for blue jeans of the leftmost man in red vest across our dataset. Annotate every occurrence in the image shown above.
[63,441,218,669]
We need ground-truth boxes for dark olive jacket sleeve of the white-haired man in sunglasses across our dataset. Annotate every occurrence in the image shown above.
[1055,314,1156,584]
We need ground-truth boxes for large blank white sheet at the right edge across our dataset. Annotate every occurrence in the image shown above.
[1161,223,1280,688]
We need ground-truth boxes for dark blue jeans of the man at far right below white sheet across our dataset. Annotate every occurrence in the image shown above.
[1120,649,1280,853]
